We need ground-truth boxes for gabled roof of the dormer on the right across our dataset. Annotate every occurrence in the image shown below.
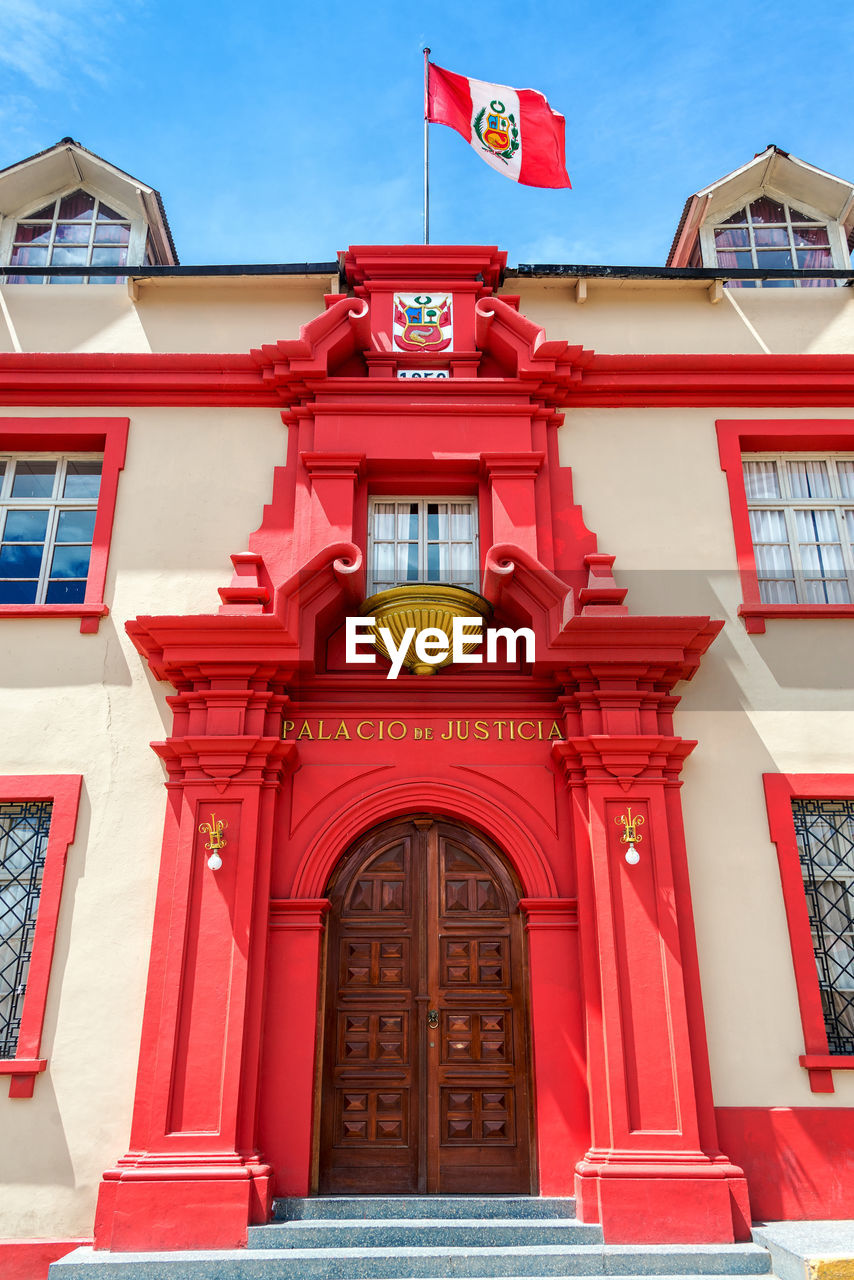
[667,143,854,266]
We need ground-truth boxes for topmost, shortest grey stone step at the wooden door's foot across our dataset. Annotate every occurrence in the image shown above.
[273,1196,575,1221]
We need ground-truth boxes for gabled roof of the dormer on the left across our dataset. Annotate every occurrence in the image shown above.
[0,138,178,266]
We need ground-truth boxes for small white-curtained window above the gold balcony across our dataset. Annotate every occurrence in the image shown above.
[367,498,479,595]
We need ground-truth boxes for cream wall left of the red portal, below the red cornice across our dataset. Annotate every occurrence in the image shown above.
[0,407,286,1238]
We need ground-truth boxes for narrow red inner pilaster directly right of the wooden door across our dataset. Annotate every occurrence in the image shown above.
[519,897,590,1196]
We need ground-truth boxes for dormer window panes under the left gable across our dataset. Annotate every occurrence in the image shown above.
[8,191,138,284]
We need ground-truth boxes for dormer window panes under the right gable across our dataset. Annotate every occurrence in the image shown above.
[712,196,836,289]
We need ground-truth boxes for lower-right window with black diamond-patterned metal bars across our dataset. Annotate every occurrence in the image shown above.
[791,800,854,1055]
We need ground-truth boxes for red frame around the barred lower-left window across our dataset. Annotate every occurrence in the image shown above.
[0,773,83,1098]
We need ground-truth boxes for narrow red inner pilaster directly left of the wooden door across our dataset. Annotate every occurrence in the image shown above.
[260,897,329,1196]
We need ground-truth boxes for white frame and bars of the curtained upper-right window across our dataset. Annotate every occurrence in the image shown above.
[741,449,854,605]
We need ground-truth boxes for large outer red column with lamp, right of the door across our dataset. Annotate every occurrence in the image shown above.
[554,737,749,1243]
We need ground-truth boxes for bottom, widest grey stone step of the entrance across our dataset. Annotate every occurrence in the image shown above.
[50,1244,769,1280]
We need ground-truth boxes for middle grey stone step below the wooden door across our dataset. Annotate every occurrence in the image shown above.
[248,1217,602,1249]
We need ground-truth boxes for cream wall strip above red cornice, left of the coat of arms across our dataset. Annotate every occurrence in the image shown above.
[0,275,338,352]
